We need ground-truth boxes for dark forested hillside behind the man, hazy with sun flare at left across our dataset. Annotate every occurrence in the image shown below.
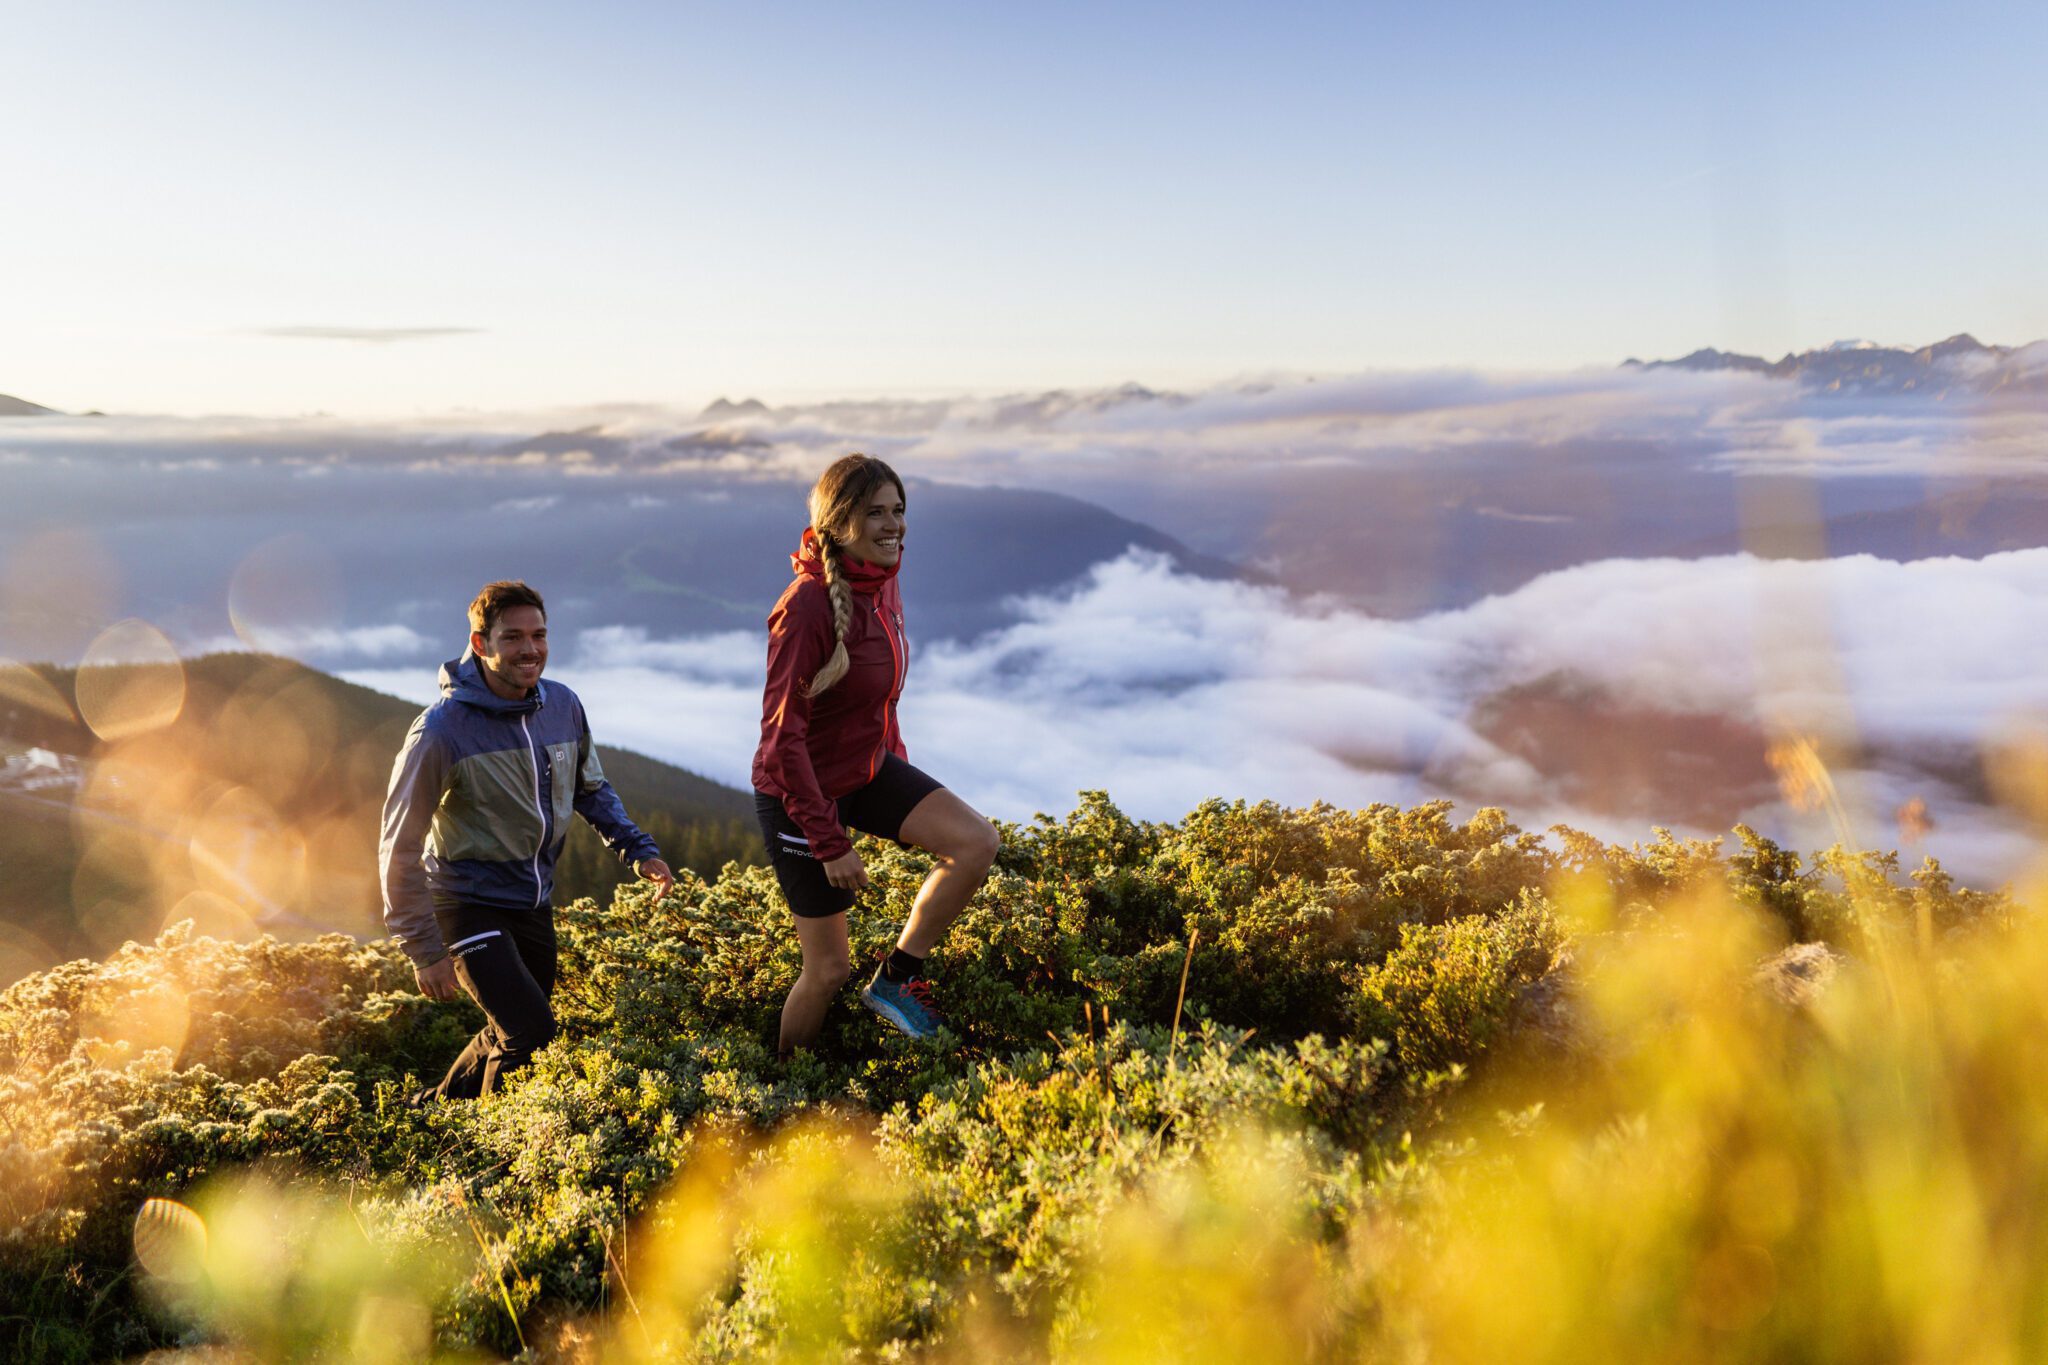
[0,653,760,982]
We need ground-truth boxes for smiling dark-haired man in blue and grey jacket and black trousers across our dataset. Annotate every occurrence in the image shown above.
[377,581,674,1099]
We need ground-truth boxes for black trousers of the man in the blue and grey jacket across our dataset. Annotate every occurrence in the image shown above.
[434,900,555,1099]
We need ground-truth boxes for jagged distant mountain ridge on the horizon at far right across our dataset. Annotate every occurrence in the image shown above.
[1622,332,2048,397]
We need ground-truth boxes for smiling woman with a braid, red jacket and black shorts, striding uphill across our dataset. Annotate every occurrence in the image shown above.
[754,454,997,1056]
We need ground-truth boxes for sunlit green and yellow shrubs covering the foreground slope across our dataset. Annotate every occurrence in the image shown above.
[0,796,2048,1365]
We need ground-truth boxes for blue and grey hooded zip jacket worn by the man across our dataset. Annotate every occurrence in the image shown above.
[377,651,659,966]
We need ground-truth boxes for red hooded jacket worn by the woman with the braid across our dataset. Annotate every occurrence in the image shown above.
[754,530,909,862]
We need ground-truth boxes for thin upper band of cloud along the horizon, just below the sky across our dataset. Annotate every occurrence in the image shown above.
[12,356,2048,485]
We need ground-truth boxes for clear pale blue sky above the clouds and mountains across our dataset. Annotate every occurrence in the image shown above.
[0,0,2048,415]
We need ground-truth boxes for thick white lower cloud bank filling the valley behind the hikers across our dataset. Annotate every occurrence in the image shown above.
[352,551,2048,878]
